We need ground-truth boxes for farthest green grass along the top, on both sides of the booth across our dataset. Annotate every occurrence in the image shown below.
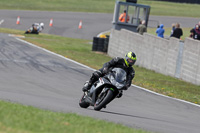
[0,0,200,17]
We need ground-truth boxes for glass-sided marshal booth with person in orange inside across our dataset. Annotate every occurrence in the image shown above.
[112,0,150,32]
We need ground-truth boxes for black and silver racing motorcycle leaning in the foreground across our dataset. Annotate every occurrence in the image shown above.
[79,68,126,111]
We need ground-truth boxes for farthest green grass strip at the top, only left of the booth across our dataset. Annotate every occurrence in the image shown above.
[0,0,115,13]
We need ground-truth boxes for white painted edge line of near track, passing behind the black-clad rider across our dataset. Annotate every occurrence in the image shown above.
[13,35,200,107]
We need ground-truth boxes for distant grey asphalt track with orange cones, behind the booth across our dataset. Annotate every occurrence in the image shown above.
[0,10,200,40]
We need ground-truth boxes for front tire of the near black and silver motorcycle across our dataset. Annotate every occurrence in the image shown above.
[94,89,114,111]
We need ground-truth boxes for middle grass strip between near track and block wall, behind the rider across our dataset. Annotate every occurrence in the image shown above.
[0,29,200,104]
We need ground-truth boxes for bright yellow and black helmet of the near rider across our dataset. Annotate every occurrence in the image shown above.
[124,52,137,67]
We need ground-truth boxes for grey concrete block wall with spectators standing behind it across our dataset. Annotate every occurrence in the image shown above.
[108,29,200,85]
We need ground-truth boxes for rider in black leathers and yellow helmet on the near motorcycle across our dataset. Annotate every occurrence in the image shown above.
[82,52,137,98]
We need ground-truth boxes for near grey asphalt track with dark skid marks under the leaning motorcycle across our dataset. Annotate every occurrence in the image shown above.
[0,33,200,133]
